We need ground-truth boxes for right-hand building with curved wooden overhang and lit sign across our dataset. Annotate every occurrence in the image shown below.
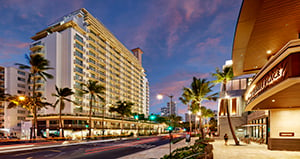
[232,0,300,151]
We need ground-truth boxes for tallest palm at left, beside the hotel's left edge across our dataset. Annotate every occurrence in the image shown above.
[16,54,53,139]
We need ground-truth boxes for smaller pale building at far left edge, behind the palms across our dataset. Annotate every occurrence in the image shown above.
[0,66,30,137]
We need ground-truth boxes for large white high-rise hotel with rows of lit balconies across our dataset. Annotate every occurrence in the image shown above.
[19,9,154,136]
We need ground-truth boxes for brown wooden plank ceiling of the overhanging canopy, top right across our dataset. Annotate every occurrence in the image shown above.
[232,0,300,75]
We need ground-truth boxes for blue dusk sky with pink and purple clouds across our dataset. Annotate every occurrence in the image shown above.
[0,0,242,116]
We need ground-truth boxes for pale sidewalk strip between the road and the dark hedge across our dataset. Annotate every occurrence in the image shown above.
[119,137,198,159]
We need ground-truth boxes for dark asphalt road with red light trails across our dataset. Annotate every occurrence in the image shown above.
[0,137,169,159]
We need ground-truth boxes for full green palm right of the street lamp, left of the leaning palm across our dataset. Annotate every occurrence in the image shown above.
[183,77,217,139]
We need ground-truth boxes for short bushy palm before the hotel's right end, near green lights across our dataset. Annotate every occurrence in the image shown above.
[109,101,134,134]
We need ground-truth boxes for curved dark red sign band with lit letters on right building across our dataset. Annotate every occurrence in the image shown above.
[246,61,287,104]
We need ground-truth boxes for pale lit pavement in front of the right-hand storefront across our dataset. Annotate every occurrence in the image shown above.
[212,139,300,159]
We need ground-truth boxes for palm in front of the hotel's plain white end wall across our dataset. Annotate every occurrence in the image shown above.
[52,86,76,137]
